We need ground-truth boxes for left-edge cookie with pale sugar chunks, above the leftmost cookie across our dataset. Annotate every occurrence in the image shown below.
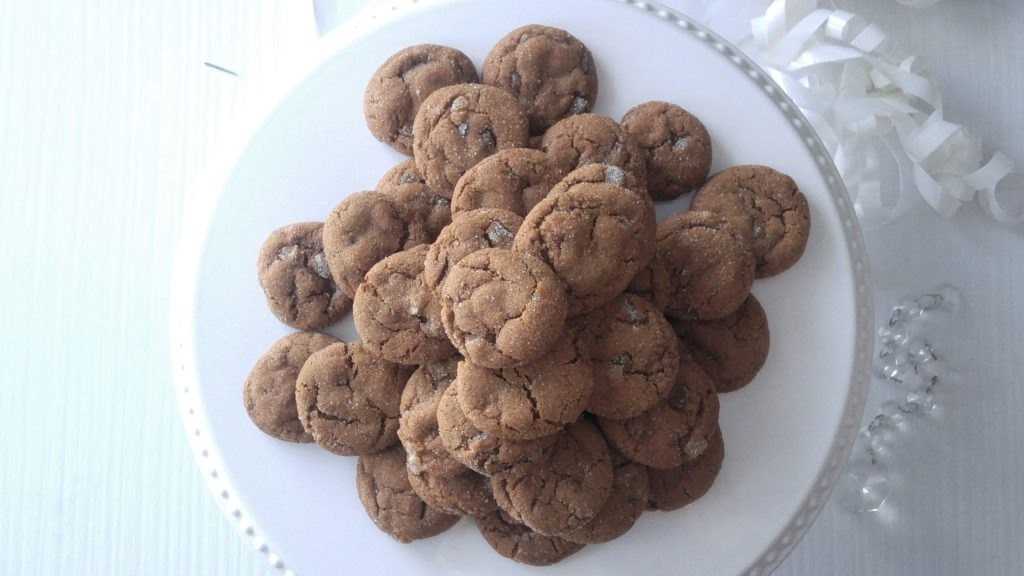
[257,222,352,330]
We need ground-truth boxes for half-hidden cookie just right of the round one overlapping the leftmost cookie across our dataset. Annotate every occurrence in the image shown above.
[398,357,466,476]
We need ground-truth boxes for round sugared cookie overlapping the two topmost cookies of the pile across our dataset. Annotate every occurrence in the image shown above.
[413,84,529,198]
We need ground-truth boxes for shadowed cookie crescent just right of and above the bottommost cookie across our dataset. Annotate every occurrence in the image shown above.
[559,454,650,544]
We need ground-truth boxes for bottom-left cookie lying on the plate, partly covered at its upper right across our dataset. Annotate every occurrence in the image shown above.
[355,446,459,542]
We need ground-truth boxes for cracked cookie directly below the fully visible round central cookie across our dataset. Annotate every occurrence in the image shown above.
[456,333,593,440]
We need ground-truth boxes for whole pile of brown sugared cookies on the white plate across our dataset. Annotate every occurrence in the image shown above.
[244,26,809,565]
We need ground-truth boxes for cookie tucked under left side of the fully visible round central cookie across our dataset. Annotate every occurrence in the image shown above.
[352,244,455,365]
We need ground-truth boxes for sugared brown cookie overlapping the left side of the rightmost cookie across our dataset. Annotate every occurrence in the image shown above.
[657,208,754,320]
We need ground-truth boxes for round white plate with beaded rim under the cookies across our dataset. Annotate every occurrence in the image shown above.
[172,0,871,576]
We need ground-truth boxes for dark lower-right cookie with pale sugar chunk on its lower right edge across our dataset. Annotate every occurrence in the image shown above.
[597,351,719,468]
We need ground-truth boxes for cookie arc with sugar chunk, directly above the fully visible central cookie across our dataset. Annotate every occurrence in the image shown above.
[423,208,522,293]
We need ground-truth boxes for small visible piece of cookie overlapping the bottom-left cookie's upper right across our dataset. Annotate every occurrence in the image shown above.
[409,468,498,517]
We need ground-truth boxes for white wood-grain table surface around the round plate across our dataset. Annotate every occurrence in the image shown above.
[0,0,1024,576]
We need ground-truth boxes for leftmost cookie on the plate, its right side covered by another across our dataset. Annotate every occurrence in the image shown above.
[242,332,338,442]
